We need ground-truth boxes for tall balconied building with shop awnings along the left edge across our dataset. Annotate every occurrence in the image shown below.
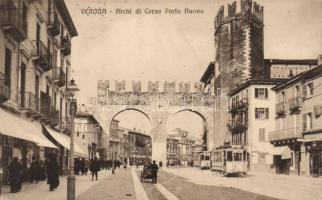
[0,0,77,181]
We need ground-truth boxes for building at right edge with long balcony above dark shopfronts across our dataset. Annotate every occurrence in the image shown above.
[269,61,322,176]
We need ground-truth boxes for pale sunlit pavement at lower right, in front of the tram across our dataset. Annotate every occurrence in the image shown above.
[165,168,322,200]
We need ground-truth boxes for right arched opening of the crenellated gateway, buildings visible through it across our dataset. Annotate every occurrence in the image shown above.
[166,109,208,166]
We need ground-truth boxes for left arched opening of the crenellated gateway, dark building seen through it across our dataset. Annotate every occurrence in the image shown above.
[108,108,152,165]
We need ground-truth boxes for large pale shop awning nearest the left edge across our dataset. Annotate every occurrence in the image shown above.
[0,108,57,148]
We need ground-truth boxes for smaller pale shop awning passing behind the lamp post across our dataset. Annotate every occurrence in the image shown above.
[45,126,88,157]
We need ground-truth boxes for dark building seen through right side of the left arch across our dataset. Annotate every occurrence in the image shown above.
[128,129,152,164]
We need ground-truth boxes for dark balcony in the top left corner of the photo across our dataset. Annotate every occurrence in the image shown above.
[0,0,28,42]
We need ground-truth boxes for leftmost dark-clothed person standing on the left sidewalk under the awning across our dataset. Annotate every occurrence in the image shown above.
[9,157,22,193]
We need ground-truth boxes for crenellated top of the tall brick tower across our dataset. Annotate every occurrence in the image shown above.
[215,0,264,30]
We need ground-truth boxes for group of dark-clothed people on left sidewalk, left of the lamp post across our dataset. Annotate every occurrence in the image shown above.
[8,154,59,193]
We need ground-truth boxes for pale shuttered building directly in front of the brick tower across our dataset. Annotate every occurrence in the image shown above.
[228,79,285,171]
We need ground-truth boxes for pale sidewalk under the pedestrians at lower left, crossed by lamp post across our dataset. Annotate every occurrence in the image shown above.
[0,170,111,200]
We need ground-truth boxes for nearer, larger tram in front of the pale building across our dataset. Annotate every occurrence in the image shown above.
[211,146,247,176]
